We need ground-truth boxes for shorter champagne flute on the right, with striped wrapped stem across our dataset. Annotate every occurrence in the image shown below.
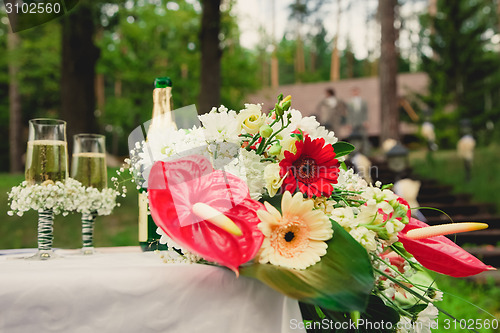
[71,134,108,254]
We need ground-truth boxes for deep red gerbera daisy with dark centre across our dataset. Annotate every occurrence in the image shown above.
[280,135,339,197]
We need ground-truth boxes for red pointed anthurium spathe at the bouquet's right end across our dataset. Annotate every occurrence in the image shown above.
[398,218,495,277]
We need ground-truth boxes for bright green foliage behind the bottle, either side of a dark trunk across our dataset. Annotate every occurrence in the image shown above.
[98,0,258,154]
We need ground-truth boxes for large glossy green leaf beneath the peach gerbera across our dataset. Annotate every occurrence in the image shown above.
[240,221,374,312]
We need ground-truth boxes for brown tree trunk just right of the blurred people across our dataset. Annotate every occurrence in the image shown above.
[379,0,399,142]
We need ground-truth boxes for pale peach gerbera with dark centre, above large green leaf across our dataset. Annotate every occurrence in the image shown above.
[257,191,333,269]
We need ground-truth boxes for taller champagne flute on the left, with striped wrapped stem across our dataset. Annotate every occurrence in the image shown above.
[25,118,68,260]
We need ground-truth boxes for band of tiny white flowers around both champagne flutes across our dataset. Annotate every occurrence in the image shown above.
[7,178,119,216]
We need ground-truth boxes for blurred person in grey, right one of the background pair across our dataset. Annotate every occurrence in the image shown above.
[347,87,368,155]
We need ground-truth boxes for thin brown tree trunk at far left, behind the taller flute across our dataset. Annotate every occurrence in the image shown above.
[7,13,26,173]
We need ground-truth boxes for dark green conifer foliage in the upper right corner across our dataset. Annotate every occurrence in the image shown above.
[422,0,500,147]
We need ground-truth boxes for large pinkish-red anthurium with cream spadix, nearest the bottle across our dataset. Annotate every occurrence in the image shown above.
[148,155,264,274]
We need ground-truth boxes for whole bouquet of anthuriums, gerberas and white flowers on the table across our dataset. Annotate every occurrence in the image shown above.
[129,96,494,332]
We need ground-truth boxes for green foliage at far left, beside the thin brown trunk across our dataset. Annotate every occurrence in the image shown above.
[0,11,61,171]
